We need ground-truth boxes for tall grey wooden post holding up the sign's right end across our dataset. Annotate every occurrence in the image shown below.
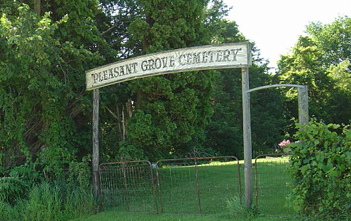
[241,68,252,207]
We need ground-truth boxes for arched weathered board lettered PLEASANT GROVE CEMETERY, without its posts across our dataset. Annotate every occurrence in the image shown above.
[86,42,251,90]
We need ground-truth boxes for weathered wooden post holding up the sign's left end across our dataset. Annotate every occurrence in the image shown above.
[92,89,100,199]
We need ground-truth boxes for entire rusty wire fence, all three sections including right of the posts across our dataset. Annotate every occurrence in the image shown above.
[100,154,294,216]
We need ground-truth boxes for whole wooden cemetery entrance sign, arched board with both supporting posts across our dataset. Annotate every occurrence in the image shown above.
[86,42,308,206]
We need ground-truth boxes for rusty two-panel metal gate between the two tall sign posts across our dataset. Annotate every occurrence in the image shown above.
[100,156,241,213]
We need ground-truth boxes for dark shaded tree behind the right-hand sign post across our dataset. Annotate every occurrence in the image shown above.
[206,20,286,158]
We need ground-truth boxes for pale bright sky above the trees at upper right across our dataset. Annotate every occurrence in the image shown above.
[223,0,351,72]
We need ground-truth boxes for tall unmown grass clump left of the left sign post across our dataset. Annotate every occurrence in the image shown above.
[0,183,95,221]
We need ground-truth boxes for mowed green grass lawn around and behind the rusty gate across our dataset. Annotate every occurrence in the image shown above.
[75,157,294,220]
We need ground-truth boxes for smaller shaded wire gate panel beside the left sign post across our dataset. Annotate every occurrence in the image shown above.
[100,161,158,213]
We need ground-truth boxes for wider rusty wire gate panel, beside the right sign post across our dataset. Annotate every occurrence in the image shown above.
[157,156,241,213]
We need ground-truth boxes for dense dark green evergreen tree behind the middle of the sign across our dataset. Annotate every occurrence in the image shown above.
[108,0,219,160]
